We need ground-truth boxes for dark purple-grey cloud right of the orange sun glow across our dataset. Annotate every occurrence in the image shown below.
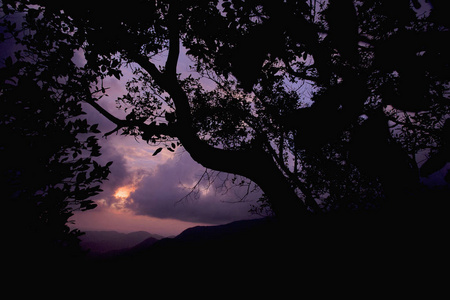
[128,153,259,224]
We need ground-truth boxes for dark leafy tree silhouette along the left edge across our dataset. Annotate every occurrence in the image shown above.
[0,4,112,267]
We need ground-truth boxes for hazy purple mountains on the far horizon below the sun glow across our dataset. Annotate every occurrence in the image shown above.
[80,231,163,255]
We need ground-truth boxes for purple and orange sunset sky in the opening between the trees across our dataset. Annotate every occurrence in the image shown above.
[72,51,260,236]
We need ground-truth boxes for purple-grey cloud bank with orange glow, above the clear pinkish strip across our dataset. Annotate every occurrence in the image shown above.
[77,57,259,224]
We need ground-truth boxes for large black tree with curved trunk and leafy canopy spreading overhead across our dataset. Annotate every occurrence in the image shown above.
[3,0,450,225]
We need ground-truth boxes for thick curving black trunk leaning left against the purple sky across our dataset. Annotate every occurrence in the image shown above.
[131,49,307,222]
